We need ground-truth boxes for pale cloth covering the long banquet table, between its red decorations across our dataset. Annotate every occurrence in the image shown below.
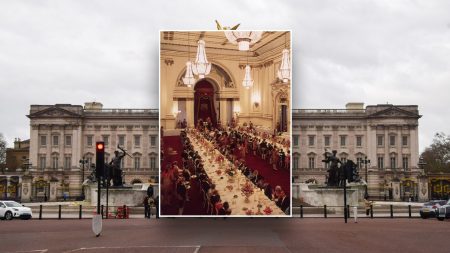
[188,133,285,215]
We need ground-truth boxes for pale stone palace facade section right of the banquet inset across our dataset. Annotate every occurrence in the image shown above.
[292,103,428,200]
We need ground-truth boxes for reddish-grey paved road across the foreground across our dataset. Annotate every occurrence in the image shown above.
[0,218,450,253]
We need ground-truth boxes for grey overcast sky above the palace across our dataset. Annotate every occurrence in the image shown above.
[0,0,450,152]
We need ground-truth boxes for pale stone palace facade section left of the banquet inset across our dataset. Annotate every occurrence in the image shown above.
[21,102,159,201]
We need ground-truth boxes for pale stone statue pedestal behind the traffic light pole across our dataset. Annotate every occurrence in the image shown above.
[86,184,147,207]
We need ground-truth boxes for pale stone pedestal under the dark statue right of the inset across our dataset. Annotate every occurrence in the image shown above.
[299,183,365,210]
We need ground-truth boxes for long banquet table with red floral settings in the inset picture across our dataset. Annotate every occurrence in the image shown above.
[187,129,286,216]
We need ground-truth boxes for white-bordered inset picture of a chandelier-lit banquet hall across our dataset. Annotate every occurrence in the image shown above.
[160,30,292,216]
